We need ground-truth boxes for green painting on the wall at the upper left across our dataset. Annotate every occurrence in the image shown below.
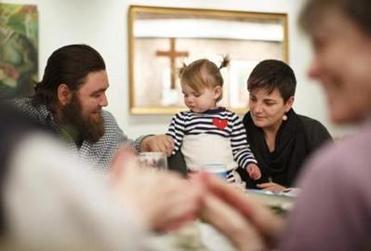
[0,3,38,99]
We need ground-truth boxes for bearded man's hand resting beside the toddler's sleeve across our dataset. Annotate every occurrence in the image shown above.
[140,134,174,156]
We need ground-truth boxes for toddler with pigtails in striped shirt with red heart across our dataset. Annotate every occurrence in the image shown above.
[167,57,261,182]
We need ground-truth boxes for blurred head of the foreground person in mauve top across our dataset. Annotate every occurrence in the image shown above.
[300,0,371,124]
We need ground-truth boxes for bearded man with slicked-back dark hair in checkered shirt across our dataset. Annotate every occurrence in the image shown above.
[13,44,172,168]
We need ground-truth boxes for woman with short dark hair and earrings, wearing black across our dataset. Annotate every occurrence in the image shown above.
[243,59,331,192]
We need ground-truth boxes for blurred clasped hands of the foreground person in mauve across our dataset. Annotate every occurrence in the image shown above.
[193,173,284,251]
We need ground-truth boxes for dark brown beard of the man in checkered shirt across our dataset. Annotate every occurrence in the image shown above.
[61,94,105,143]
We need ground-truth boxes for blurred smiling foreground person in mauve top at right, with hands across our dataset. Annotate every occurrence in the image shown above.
[198,0,371,251]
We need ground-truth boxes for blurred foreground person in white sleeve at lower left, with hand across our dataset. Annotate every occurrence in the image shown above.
[0,104,202,251]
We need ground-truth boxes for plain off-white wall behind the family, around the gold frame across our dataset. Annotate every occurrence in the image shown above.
[0,0,356,137]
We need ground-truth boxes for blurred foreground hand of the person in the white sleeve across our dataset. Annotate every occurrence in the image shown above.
[110,149,203,231]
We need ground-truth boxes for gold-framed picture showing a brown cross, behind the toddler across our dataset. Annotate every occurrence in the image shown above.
[128,6,288,114]
